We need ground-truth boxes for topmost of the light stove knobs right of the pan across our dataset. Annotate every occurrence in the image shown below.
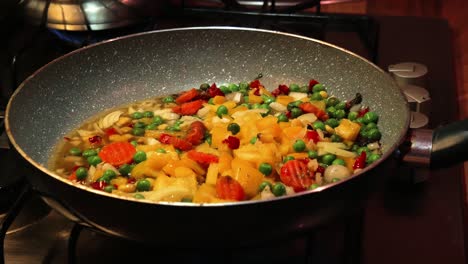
[388,62,428,87]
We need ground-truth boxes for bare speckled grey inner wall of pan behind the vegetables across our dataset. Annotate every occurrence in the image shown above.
[7,28,409,165]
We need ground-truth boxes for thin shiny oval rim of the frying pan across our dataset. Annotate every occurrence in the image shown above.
[5,26,410,207]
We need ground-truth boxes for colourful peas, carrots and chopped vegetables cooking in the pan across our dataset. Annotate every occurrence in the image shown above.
[51,79,381,203]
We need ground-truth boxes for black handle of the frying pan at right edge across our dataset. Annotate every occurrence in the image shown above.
[430,119,468,169]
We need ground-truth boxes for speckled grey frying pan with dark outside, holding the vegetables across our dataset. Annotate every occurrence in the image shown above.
[6,27,467,247]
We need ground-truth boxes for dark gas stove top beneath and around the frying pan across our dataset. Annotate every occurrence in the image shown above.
[0,1,465,264]
